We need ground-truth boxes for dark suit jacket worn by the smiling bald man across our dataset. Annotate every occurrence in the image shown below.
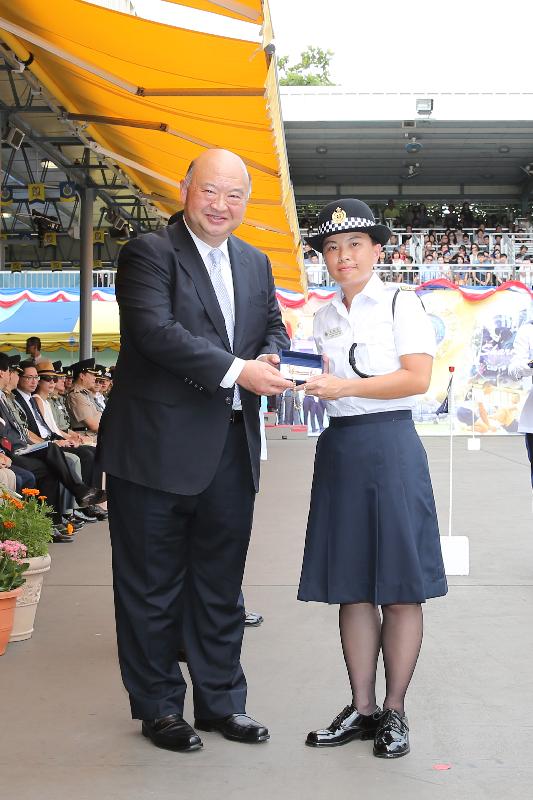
[97,212,289,495]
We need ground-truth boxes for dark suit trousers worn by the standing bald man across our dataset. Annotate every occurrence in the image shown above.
[107,423,255,719]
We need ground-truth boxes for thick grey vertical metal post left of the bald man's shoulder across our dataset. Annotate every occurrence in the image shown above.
[80,188,94,360]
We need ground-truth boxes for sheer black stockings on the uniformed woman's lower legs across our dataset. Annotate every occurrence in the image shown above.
[339,603,423,714]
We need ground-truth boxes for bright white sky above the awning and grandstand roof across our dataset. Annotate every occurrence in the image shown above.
[130,0,533,92]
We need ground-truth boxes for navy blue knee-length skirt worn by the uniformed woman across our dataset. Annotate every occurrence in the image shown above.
[298,411,448,606]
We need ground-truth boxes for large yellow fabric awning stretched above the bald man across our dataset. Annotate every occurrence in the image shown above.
[0,0,305,291]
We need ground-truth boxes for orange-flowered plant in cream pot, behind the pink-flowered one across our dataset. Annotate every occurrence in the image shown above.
[0,489,52,642]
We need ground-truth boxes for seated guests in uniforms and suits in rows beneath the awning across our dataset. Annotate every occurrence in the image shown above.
[0,336,113,542]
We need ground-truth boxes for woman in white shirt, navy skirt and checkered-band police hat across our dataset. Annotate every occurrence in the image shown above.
[298,200,447,758]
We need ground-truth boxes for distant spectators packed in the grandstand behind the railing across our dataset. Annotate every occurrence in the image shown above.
[304,200,533,287]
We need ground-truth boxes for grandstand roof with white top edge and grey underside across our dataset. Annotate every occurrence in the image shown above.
[282,87,533,203]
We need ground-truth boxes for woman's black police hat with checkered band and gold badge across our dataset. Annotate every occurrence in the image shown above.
[307,198,391,251]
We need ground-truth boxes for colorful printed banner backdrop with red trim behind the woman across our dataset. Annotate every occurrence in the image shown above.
[277,280,533,435]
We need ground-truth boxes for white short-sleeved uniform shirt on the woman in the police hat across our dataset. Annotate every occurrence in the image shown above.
[313,273,437,417]
